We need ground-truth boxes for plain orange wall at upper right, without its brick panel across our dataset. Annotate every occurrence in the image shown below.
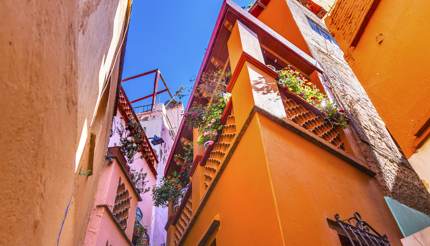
[327,0,430,157]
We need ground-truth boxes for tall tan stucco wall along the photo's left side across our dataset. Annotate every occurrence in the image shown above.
[0,0,128,245]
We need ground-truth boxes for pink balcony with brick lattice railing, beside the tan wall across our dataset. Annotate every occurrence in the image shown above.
[84,147,141,246]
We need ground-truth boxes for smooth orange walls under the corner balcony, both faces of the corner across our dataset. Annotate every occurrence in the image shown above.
[184,113,400,245]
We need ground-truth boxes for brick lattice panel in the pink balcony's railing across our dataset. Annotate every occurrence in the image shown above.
[112,179,131,230]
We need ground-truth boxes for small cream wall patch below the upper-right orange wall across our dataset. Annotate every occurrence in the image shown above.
[409,138,430,192]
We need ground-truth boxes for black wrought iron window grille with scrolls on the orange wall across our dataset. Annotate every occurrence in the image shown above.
[334,212,390,246]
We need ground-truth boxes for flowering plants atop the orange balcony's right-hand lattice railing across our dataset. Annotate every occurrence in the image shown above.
[278,66,348,128]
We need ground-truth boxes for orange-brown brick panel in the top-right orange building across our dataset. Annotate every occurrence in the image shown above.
[326,0,378,50]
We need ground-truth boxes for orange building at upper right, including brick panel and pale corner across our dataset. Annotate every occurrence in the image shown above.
[325,0,430,192]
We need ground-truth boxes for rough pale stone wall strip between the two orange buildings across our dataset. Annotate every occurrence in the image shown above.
[286,0,430,214]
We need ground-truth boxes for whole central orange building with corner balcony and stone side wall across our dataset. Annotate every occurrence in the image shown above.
[165,0,430,245]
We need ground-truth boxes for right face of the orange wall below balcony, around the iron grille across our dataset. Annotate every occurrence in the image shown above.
[259,116,401,245]
